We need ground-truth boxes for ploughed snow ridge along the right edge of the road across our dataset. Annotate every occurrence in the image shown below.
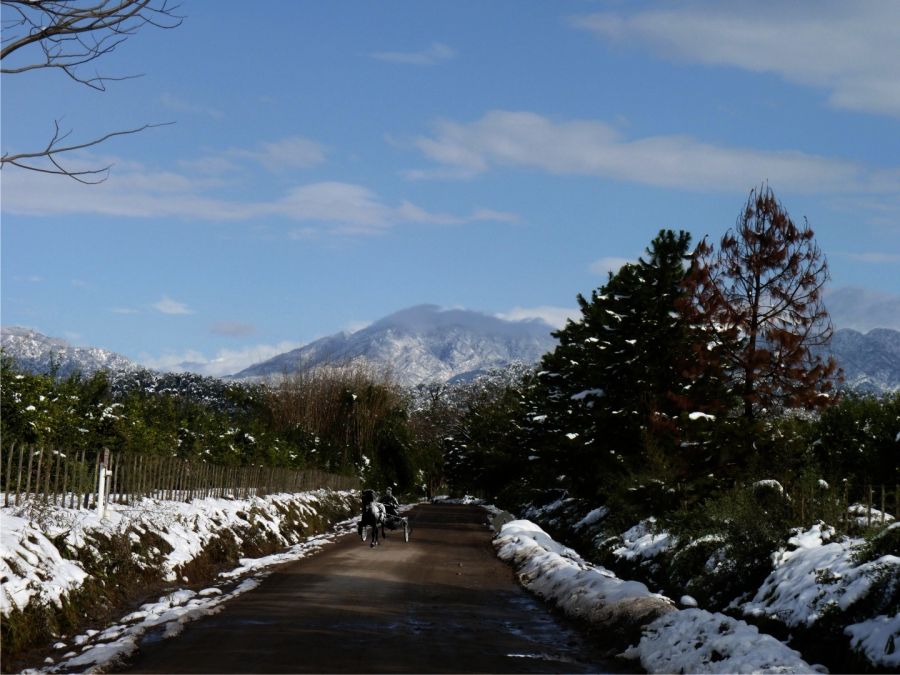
[494,520,821,673]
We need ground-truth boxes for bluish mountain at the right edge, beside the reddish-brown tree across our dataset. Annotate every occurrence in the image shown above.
[831,328,900,393]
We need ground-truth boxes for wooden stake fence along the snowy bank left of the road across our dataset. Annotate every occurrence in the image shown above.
[0,443,359,508]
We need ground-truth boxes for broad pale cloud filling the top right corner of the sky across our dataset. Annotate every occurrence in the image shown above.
[572,0,900,116]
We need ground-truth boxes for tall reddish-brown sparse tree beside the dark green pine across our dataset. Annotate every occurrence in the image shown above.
[692,186,837,422]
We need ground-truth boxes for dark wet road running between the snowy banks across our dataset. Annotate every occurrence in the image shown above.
[126,505,616,673]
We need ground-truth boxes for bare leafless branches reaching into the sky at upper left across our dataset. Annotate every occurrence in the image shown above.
[0,0,183,183]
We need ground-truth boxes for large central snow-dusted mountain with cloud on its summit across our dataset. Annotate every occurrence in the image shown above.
[232,305,556,386]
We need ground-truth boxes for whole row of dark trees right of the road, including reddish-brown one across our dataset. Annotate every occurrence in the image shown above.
[445,185,900,523]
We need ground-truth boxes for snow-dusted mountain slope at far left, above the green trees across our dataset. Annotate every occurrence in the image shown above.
[0,326,140,377]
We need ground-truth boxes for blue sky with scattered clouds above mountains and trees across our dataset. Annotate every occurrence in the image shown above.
[0,0,900,374]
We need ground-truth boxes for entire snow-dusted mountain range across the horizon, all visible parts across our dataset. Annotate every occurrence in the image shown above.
[2,312,900,393]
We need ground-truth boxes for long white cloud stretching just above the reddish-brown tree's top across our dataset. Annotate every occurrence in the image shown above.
[407,110,900,194]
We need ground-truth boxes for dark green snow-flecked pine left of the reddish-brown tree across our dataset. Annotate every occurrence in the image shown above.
[530,230,705,500]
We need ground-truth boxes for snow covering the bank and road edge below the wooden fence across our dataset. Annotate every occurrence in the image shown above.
[0,490,355,672]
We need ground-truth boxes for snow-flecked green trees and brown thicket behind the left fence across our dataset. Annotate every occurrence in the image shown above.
[0,356,435,491]
